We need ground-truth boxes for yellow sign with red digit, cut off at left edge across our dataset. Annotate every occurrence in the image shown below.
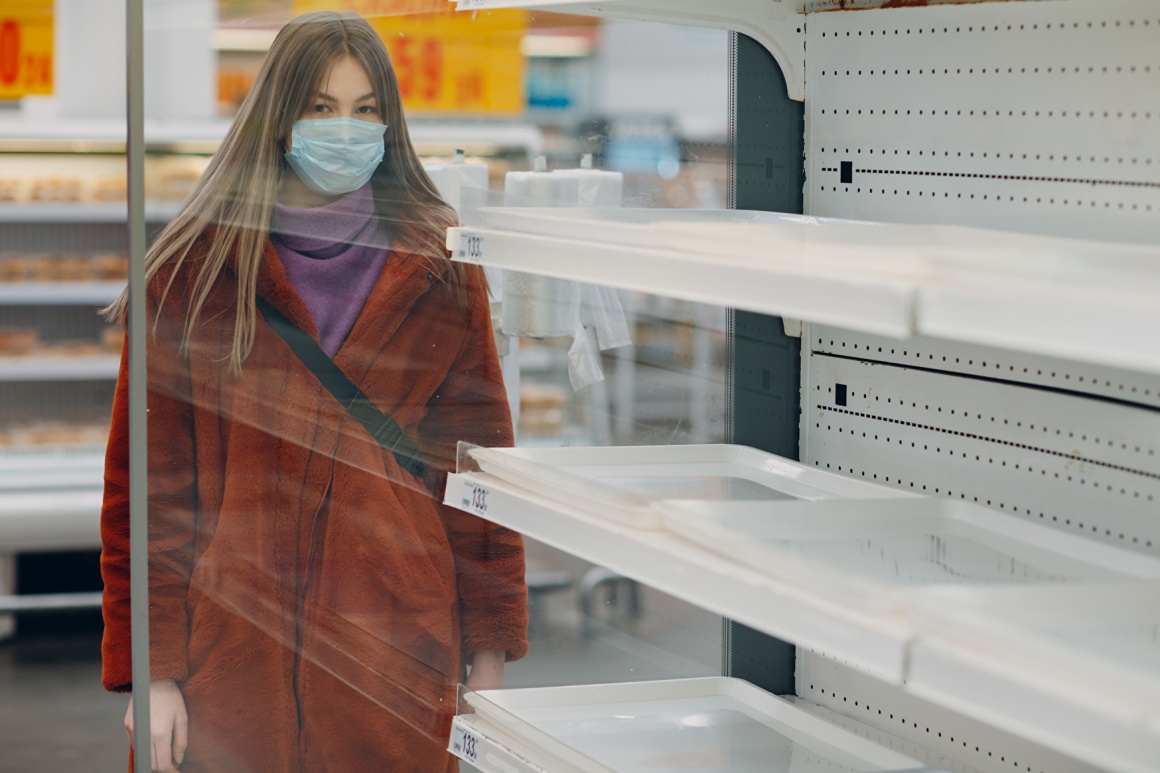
[0,0,52,100]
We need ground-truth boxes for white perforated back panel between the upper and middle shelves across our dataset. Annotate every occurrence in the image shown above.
[803,348,1160,556]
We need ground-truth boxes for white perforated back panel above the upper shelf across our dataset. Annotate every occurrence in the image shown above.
[806,0,1160,241]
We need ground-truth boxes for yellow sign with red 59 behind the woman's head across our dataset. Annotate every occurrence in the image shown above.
[293,0,528,115]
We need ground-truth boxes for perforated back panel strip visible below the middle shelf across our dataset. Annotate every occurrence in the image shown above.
[797,650,1099,773]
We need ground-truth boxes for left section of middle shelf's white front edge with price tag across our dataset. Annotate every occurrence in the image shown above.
[444,472,911,684]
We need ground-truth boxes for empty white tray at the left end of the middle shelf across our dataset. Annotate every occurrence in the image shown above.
[469,445,905,528]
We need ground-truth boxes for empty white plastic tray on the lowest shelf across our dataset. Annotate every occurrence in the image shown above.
[464,677,921,773]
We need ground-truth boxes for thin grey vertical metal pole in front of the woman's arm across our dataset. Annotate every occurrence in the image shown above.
[125,0,151,773]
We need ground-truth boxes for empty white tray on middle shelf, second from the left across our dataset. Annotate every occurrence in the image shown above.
[658,498,1160,598]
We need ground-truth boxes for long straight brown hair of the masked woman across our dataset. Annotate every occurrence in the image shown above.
[104,10,465,375]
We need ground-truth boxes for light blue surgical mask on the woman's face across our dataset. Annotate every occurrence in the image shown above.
[285,118,386,196]
